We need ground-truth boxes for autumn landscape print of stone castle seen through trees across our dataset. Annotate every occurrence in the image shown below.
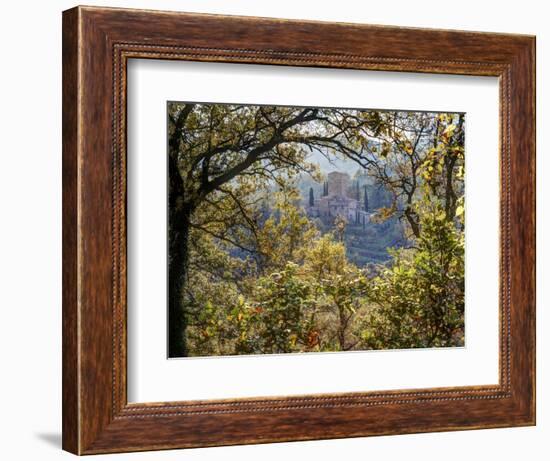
[167,101,465,357]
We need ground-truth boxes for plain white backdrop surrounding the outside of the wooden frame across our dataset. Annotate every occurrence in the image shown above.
[0,0,550,461]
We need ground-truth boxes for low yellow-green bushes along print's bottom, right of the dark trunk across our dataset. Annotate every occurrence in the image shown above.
[189,228,369,355]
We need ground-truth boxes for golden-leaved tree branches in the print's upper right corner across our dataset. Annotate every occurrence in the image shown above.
[340,111,464,238]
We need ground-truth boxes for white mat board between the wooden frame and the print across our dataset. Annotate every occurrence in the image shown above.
[127,59,499,402]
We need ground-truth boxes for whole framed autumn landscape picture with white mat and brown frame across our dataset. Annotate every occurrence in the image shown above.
[63,7,535,454]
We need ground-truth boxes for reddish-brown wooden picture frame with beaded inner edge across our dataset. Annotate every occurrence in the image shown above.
[63,7,535,454]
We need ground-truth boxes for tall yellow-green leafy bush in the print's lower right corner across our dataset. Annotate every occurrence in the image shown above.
[362,195,464,349]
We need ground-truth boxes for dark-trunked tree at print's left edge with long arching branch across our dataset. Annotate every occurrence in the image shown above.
[168,103,388,356]
